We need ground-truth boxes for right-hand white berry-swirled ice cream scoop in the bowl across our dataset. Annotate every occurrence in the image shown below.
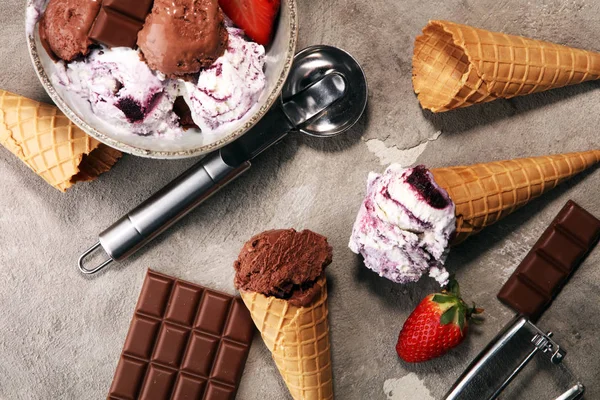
[185,27,266,133]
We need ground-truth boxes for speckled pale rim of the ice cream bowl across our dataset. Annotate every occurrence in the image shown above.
[26,0,298,159]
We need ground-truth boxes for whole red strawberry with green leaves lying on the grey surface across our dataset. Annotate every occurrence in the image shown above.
[396,278,483,362]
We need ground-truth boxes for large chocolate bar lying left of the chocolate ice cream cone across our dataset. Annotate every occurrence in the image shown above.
[108,270,254,400]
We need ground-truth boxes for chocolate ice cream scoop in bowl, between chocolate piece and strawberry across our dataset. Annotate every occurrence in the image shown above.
[137,0,228,77]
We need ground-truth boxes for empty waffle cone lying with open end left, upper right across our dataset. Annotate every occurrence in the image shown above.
[413,21,600,112]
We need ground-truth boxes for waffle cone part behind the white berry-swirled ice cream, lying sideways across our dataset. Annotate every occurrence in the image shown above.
[431,150,600,245]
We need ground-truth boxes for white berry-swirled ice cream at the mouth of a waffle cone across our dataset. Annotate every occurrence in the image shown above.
[349,164,456,285]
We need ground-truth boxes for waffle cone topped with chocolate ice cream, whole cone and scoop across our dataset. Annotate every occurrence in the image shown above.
[235,229,333,400]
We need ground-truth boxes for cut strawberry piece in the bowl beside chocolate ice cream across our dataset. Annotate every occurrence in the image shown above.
[219,0,281,46]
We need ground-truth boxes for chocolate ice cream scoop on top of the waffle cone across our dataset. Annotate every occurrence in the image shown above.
[234,229,332,307]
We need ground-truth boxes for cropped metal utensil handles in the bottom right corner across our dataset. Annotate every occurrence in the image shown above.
[444,315,584,400]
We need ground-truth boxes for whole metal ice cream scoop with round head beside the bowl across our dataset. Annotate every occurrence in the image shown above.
[78,45,367,274]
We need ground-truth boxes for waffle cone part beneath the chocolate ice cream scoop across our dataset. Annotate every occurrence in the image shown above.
[241,278,333,400]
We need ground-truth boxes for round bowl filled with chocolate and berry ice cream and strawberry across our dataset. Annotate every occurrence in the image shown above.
[26,0,297,158]
